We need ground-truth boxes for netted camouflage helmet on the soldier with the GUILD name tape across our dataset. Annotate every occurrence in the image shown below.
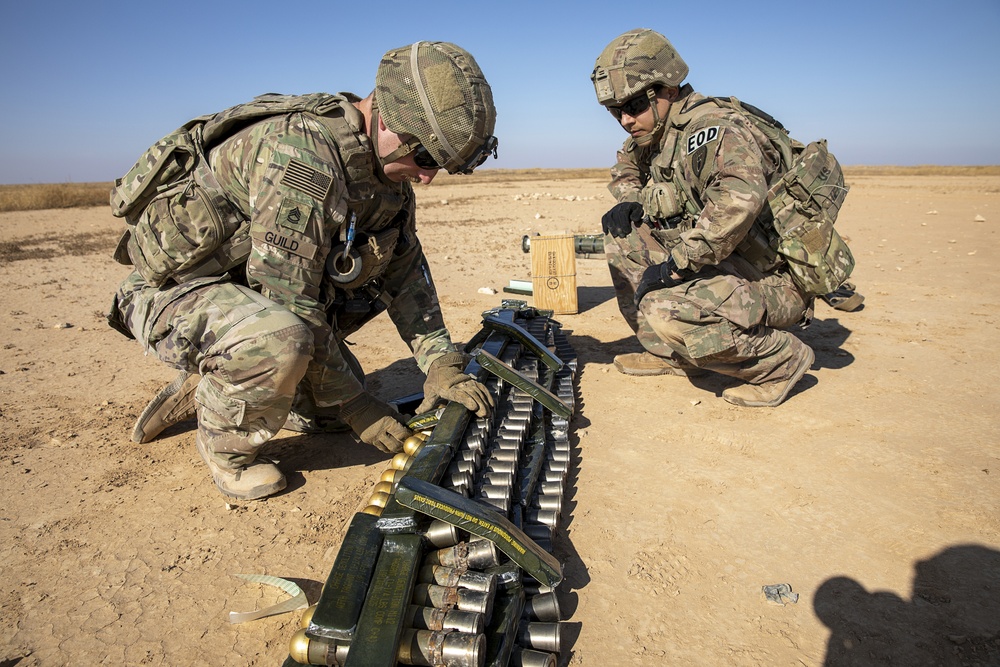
[375,42,497,174]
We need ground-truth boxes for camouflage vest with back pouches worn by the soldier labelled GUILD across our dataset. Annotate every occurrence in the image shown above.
[111,93,412,289]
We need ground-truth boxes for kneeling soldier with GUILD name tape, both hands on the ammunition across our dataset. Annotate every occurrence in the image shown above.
[109,42,497,500]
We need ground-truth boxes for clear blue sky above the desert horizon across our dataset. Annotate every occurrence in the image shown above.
[0,0,1000,183]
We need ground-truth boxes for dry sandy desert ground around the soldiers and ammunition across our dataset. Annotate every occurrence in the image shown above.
[0,171,1000,667]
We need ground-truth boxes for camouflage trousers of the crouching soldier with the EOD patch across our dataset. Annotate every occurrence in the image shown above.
[604,234,810,384]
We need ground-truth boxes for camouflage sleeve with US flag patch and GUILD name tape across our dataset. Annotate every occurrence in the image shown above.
[211,114,363,406]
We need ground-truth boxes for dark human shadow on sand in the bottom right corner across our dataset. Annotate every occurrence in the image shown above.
[813,544,1000,667]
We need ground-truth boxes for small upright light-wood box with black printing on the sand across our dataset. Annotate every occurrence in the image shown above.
[531,234,578,315]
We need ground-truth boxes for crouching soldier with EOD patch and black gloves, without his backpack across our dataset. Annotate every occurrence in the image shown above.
[591,29,814,407]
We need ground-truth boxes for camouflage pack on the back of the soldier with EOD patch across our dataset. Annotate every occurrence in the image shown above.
[765,140,854,295]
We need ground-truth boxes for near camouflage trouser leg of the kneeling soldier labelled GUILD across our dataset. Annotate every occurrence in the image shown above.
[115,273,313,467]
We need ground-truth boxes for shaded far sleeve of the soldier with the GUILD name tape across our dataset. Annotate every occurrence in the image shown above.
[385,204,455,373]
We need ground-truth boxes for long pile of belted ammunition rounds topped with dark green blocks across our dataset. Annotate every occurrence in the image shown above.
[284,301,577,667]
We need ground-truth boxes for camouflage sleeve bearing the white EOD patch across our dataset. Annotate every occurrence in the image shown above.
[671,113,768,270]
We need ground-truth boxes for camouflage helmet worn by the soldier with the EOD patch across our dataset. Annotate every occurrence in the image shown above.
[590,28,688,106]
